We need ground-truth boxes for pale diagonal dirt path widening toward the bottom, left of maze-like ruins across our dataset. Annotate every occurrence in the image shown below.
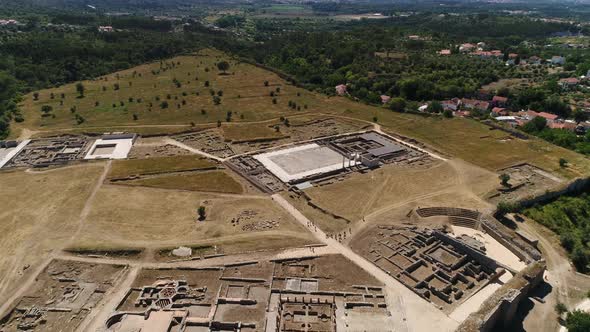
[272,194,458,331]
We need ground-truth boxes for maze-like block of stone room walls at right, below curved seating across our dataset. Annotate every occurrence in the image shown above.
[352,226,505,312]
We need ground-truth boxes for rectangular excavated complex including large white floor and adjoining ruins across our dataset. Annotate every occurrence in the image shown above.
[228,131,431,193]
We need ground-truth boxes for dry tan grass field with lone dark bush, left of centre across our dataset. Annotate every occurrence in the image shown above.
[72,185,313,251]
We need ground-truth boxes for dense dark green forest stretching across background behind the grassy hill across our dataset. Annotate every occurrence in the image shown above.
[0,1,582,137]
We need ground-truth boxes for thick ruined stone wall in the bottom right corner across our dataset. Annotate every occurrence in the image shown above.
[456,261,546,332]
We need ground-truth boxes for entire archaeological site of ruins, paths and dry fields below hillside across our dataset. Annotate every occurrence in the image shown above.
[0,102,561,332]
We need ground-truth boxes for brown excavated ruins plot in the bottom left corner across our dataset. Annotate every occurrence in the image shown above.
[0,260,127,332]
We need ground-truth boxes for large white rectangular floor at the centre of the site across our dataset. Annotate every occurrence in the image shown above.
[254,143,358,182]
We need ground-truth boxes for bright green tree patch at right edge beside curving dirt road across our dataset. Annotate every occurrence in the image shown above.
[524,193,590,273]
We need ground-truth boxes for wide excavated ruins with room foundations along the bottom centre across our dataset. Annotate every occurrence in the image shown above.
[105,255,401,332]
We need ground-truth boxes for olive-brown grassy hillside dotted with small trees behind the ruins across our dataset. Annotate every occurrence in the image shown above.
[14,50,590,178]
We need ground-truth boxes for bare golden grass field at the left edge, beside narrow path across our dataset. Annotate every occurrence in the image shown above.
[0,163,103,300]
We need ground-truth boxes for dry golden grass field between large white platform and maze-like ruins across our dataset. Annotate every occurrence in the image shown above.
[294,160,499,232]
